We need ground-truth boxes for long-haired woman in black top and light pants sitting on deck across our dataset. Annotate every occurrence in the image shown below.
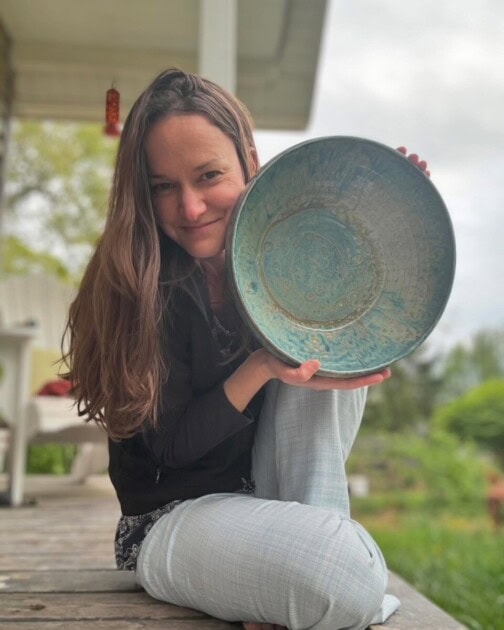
[67,70,422,630]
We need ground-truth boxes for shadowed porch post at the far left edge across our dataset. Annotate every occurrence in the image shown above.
[0,22,14,273]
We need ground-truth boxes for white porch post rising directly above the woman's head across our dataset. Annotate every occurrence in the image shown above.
[198,0,237,93]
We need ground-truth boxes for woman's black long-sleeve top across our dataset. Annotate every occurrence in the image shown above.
[109,273,262,516]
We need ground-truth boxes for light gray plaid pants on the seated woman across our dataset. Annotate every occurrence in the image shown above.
[137,381,387,630]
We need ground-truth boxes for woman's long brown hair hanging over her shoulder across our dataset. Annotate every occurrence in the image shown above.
[64,69,255,439]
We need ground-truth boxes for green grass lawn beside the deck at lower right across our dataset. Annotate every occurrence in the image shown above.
[352,499,504,630]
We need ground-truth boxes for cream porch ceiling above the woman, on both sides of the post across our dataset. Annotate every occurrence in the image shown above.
[0,0,326,129]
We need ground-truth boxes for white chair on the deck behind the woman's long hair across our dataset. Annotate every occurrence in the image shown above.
[0,275,108,506]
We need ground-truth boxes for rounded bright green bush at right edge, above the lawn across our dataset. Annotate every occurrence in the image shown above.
[434,379,504,466]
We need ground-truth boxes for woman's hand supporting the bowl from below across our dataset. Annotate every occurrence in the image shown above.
[267,354,391,390]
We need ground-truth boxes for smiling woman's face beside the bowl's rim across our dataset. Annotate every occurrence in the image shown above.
[145,114,255,259]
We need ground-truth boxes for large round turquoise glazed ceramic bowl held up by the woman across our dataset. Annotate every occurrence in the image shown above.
[226,136,455,377]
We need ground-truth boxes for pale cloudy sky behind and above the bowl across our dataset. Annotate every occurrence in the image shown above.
[256,0,504,348]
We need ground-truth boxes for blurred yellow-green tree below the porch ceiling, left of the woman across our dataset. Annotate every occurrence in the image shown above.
[4,121,117,277]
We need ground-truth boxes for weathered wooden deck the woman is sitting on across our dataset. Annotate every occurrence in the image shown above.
[0,477,463,630]
